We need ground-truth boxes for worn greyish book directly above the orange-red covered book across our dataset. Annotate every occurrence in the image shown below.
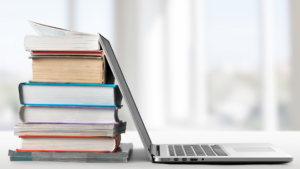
[14,121,126,137]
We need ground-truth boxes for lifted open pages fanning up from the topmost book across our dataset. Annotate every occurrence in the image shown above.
[28,21,96,36]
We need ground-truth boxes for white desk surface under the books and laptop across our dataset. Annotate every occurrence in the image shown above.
[0,131,300,169]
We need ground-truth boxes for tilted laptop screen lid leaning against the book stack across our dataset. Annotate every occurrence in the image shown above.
[99,34,152,154]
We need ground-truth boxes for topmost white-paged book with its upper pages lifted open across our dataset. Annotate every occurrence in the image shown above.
[24,21,102,51]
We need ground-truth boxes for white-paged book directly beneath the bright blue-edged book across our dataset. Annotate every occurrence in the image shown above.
[19,106,119,124]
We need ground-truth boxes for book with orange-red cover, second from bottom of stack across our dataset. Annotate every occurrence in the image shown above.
[16,135,121,153]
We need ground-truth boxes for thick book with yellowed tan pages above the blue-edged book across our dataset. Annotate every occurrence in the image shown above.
[29,55,114,84]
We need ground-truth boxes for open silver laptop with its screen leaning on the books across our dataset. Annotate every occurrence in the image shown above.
[99,34,293,163]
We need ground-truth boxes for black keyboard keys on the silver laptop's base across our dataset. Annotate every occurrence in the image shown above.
[168,144,228,156]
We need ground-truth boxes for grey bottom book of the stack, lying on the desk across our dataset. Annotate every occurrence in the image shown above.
[8,143,133,163]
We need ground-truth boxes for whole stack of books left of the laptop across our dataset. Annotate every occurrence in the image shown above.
[9,22,133,162]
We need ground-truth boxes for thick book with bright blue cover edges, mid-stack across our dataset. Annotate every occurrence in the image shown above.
[19,83,122,107]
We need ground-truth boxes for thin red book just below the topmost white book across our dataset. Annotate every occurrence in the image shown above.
[31,51,103,56]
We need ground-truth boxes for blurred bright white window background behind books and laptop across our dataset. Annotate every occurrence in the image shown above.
[0,0,300,131]
